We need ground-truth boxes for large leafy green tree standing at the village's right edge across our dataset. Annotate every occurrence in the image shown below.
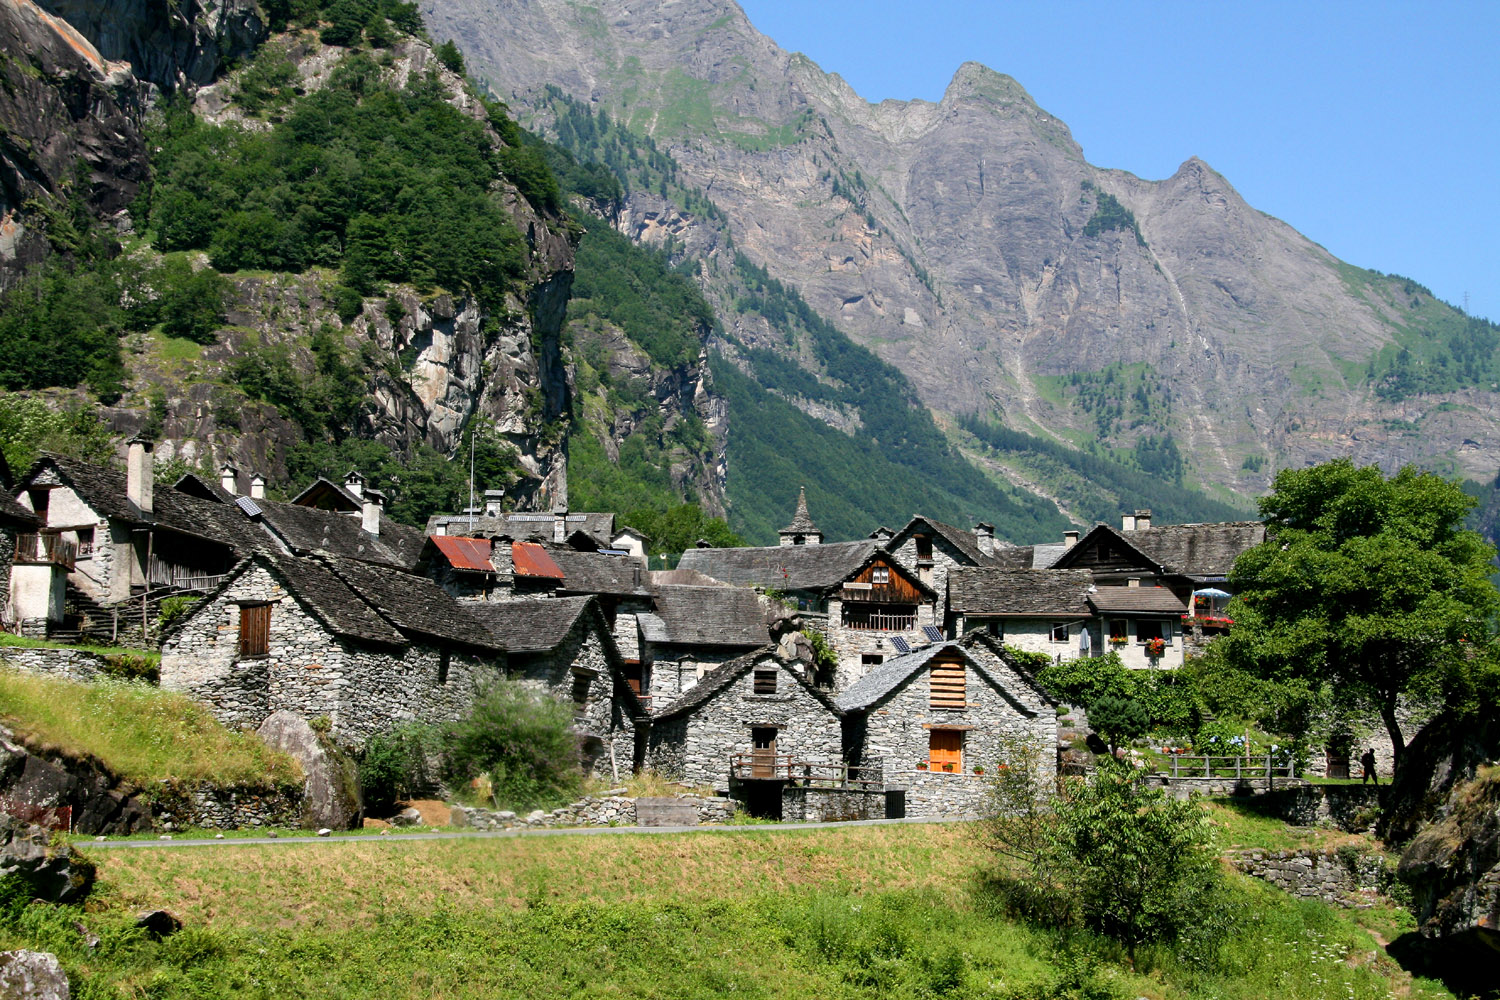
[1221,459,1500,769]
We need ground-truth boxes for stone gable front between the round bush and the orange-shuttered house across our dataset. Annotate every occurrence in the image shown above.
[647,652,843,789]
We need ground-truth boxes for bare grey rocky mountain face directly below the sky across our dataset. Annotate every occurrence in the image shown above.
[428,0,1500,493]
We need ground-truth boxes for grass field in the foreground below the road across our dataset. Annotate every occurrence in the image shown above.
[0,825,1446,1000]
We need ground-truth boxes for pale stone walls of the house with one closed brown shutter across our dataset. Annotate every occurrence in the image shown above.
[162,562,501,747]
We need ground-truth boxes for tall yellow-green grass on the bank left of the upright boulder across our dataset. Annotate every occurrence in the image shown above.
[0,669,302,787]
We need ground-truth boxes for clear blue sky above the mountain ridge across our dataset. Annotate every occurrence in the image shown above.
[741,0,1500,321]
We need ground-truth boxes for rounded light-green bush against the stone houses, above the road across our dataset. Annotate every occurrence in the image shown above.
[443,679,582,813]
